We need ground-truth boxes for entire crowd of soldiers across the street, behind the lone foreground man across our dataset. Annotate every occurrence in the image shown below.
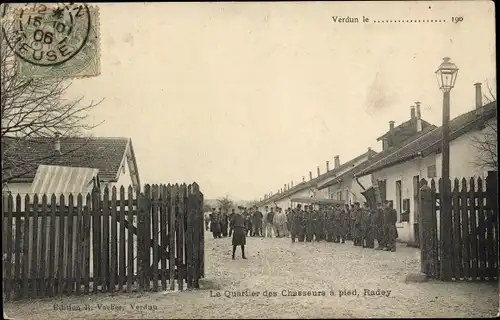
[205,201,398,252]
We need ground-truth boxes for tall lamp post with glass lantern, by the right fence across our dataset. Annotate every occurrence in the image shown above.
[436,57,458,280]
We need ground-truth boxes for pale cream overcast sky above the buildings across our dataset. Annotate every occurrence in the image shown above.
[68,1,496,200]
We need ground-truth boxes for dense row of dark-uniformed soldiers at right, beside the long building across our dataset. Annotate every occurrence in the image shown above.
[288,201,398,252]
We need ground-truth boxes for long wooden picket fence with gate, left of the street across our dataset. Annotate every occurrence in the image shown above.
[2,183,204,300]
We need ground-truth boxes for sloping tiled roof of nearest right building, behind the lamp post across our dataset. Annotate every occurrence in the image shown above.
[357,101,497,176]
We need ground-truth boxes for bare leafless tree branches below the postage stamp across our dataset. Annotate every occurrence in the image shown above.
[0,9,101,184]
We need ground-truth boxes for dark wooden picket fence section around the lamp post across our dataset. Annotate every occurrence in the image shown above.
[420,173,499,281]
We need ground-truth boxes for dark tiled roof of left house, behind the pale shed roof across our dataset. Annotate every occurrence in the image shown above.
[2,137,130,182]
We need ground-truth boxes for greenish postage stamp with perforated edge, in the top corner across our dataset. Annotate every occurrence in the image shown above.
[2,3,100,78]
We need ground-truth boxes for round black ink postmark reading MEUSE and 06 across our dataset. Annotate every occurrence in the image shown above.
[2,3,91,67]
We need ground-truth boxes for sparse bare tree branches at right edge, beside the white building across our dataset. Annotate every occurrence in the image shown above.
[471,82,498,170]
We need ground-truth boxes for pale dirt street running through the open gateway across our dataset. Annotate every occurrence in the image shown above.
[4,235,499,319]
